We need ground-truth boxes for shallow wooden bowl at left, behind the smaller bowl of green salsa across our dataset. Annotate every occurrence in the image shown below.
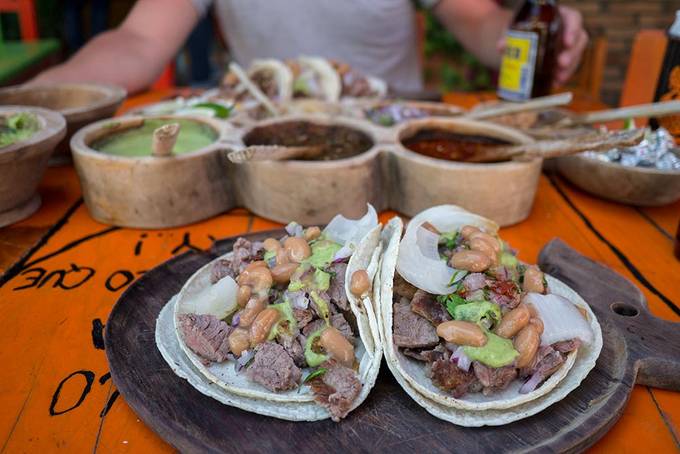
[0,83,127,164]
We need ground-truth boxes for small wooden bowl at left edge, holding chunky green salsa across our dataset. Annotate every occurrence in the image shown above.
[0,106,66,227]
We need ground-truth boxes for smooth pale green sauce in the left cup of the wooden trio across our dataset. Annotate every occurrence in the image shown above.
[90,118,217,156]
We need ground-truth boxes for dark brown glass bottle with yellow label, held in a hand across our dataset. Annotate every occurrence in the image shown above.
[498,0,562,101]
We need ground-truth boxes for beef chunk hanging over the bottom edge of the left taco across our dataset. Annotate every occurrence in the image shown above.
[310,361,361,422]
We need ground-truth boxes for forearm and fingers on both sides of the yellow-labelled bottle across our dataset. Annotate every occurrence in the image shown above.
[434,0,588,85]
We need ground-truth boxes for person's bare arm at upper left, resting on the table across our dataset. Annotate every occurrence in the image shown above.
[31,0,198,93]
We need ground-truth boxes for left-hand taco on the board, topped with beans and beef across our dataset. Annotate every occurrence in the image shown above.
[157,206,382,421]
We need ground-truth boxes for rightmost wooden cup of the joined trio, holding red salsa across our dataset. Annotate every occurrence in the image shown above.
[387,118,542,226]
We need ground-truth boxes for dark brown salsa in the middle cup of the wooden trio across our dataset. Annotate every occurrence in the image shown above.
[243,121,373,161]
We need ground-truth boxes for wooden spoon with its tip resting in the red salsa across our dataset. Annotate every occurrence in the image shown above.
[465,129,644,162]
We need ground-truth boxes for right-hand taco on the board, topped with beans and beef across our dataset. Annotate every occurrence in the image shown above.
[378,205,602,418]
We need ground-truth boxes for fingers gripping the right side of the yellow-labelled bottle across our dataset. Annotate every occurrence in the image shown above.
[554,6,588,85]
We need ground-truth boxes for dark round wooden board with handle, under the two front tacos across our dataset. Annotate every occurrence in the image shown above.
[105,231,680,454]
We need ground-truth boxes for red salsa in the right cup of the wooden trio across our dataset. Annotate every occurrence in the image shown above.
[401,128,510,161]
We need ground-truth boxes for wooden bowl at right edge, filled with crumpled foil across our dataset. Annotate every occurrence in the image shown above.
[557,155,680,206]
